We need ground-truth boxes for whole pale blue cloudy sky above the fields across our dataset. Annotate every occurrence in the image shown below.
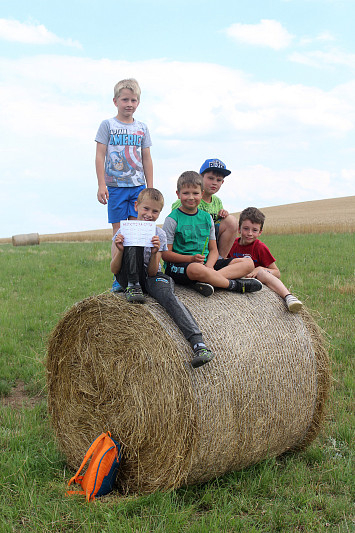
[0,0,355,237]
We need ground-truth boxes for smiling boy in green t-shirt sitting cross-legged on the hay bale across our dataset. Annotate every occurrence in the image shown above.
[162,170,262,296]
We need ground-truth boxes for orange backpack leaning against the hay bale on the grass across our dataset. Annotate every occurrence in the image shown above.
[67,431,121,501]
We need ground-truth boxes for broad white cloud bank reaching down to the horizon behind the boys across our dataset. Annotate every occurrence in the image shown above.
[0,56,355,236]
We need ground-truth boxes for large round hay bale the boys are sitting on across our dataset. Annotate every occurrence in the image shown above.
[47,287,330,493]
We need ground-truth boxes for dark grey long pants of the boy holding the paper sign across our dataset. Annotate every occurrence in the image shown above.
[116,246,202,346]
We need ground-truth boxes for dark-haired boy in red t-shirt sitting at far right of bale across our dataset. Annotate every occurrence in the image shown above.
[228,207,302,313]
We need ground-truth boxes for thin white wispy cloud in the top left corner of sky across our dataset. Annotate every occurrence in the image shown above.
[0,19,81,48]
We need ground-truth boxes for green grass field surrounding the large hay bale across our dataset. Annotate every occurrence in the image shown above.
[0,234,355,533]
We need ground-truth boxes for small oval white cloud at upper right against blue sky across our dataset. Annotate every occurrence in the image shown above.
[226,19,293,50]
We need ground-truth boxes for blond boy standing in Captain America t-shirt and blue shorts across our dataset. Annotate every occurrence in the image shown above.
[95,78,153,291]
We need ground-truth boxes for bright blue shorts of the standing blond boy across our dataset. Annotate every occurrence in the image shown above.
[107,185,145,224]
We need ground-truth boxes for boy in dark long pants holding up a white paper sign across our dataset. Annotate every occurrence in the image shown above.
[111,188,214,368]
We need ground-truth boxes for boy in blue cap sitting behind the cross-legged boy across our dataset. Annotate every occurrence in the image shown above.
[171,159,238,257]
